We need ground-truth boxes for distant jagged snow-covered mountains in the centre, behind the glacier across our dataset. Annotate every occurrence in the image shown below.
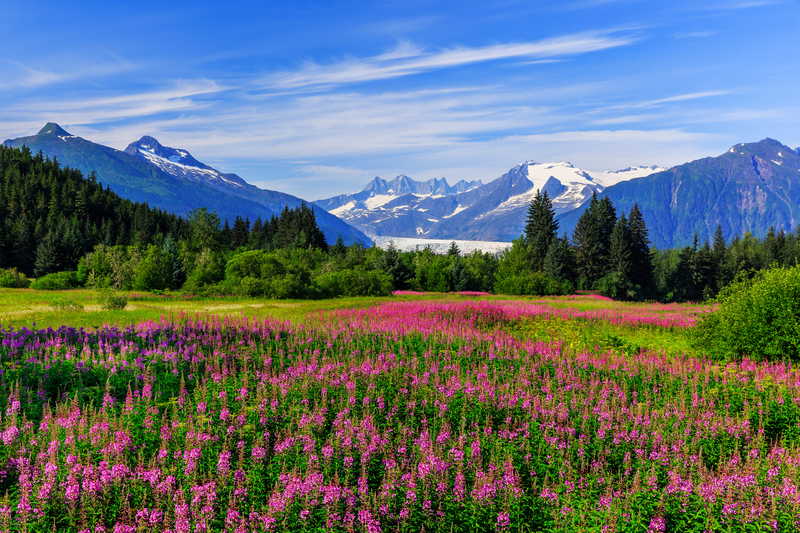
[315,161,664,241]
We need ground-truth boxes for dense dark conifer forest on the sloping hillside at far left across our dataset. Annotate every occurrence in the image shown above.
[0,142,187,276]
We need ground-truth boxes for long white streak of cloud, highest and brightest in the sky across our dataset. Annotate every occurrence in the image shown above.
[263,32,637,89]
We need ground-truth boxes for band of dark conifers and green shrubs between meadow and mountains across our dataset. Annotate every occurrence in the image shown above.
[0,143,800,301]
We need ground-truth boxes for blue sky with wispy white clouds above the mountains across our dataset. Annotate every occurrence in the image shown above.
[0,0,800,200]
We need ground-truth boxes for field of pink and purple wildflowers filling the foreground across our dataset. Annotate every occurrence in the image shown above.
[0,294,800,533]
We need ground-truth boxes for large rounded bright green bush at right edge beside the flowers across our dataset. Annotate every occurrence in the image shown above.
[693,266,800,360]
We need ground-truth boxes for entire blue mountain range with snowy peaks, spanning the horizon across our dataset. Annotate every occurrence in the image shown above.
[3,123,800,248]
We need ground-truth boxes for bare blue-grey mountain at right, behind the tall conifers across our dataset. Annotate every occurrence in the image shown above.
[559,139,800,248]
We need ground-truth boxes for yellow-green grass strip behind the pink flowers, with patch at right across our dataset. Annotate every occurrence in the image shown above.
[0,289,696,355]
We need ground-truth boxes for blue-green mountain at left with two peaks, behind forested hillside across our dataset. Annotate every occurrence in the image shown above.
[3,123,371,244]
